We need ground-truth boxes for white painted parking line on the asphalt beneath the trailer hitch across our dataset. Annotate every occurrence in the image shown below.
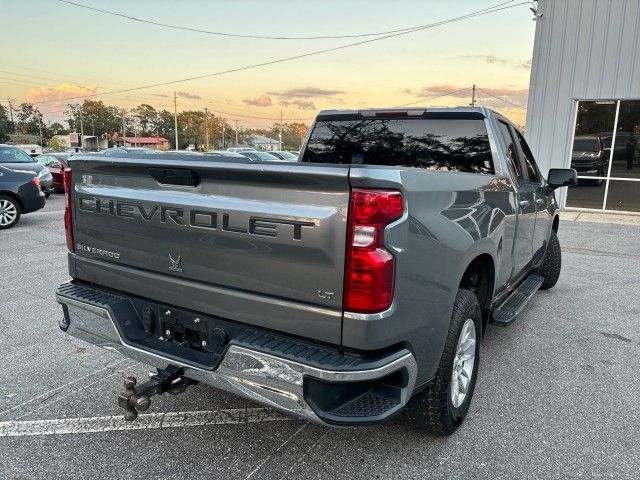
[0,408,294,437]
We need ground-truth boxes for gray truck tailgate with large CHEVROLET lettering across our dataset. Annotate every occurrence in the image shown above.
[72,155,349,343]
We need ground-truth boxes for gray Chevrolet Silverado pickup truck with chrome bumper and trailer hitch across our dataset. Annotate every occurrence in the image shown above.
[57,107,576,435]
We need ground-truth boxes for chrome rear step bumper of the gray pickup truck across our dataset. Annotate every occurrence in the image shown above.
[56,284,417,426]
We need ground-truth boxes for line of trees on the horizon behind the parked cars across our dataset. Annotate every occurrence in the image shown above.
[0,99,308,150]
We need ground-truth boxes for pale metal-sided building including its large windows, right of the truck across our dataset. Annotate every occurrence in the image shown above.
[526,0,640,212]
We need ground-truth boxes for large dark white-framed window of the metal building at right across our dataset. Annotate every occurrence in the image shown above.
[566,100,640,212]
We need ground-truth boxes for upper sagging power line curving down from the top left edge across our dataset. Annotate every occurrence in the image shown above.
[58,0,528,40]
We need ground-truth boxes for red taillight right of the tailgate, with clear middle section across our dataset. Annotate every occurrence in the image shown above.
[344,189,404,313]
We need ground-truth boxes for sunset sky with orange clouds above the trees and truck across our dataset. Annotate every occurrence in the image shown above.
[0,0,535,128]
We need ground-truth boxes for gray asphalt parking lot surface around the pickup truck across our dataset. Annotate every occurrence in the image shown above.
[0,195,640,479]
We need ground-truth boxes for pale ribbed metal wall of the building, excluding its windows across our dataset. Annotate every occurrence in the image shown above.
[525,0,640,180]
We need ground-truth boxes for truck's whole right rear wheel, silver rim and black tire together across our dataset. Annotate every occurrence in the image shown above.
[407,289,482,436]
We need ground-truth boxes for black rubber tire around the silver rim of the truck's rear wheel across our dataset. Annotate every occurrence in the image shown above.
[407,289,482,436]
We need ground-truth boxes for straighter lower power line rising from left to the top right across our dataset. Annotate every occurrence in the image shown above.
[32,2,528,105]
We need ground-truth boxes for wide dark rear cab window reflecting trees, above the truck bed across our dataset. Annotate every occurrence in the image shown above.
[302,118,494,175]
